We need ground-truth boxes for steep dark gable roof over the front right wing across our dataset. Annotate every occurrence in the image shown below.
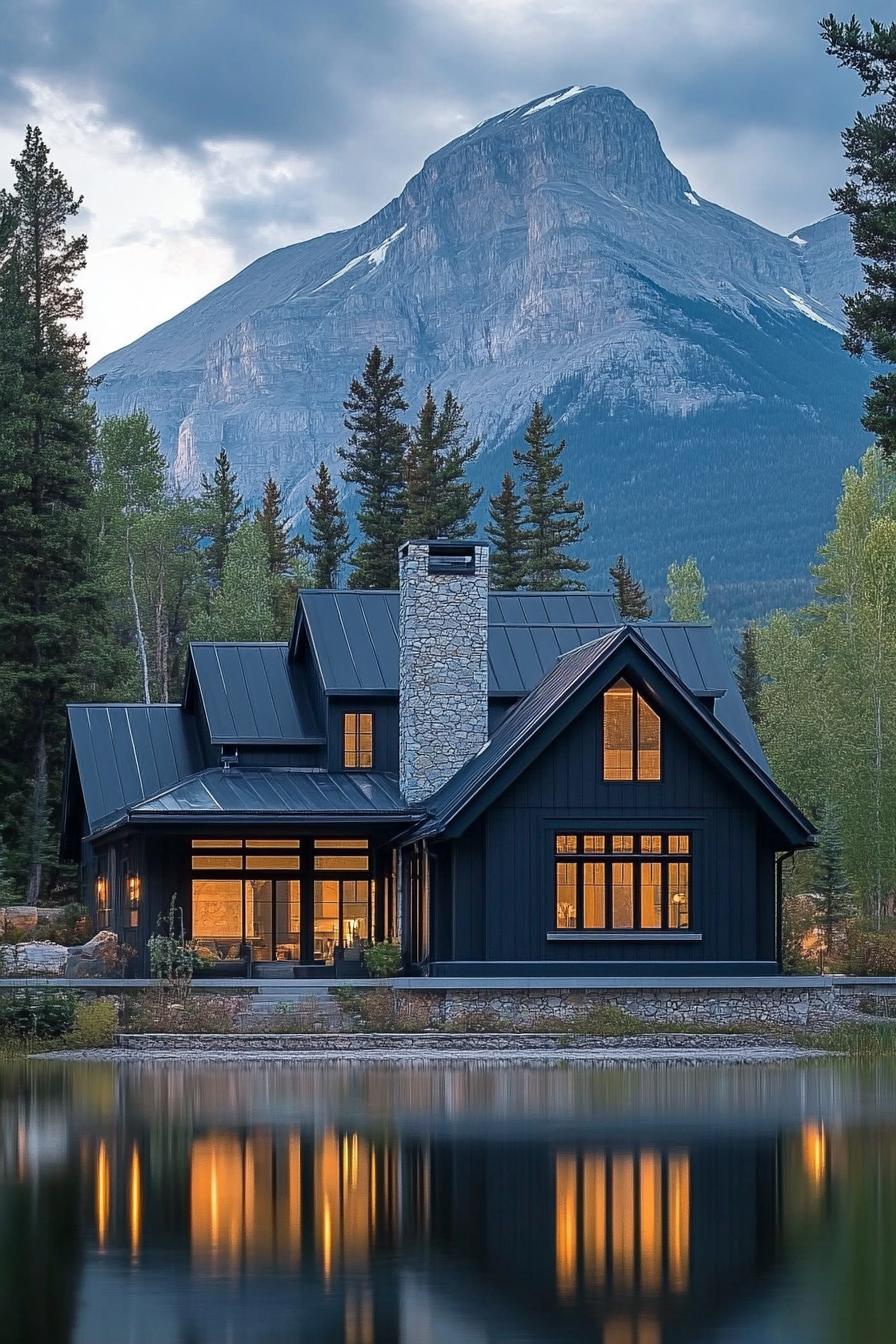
[418,624,813,841]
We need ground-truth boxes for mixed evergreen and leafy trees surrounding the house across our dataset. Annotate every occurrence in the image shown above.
[0,24,896,946]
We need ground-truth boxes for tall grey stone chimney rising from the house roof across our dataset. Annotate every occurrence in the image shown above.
[398,540,489,802]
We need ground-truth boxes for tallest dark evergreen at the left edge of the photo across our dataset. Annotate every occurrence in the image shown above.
[0,126,102,903]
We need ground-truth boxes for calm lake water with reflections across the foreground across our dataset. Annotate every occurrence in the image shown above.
[0,1060,896,1344]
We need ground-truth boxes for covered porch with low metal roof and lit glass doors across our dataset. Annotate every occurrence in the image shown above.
[82,767,410,978]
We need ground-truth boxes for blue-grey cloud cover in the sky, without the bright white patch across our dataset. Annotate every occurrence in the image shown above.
[0,0,881,270]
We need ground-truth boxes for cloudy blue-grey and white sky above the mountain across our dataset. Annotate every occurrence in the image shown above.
[0,0,870,358]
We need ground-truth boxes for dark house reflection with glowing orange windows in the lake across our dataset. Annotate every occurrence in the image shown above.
[70,1122,830,1344]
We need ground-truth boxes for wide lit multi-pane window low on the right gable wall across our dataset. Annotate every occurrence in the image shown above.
[553,833,690,931]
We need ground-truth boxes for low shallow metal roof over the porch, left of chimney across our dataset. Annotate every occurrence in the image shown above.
[130,766,419,821]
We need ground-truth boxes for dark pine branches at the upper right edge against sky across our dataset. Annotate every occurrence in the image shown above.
[821,15,896,456]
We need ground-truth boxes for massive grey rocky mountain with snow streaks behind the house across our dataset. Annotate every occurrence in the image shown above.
[94,86,868,626]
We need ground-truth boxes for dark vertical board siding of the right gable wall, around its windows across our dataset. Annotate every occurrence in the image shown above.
[433,702,775,969]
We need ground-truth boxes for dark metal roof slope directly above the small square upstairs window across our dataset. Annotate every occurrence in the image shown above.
[184,642,324,746]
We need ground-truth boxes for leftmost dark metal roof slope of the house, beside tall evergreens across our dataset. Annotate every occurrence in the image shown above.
[69,704,201,832]
